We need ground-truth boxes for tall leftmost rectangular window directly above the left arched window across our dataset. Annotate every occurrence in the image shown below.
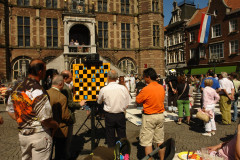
[17,17,30,47]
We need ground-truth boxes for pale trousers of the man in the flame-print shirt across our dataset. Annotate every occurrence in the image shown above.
[19,132,52,160]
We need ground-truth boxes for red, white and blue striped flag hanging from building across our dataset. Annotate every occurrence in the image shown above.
[198,14,211,43]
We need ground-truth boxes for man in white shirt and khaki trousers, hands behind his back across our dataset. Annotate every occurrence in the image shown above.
[219,72,234,125]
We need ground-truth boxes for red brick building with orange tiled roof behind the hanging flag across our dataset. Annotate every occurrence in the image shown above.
[185,0,240,75]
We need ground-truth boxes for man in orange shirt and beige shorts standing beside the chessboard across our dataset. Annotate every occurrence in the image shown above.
[136,68,165,160]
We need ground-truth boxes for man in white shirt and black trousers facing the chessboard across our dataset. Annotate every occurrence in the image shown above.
[97,70,130,148]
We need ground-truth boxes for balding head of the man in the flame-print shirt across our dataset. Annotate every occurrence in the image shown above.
[28,59,46,78]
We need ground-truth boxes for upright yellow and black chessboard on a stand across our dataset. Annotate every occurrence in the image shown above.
[73,63,110,102]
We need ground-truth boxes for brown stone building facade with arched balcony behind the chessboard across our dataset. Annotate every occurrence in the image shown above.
[0,0,165,79]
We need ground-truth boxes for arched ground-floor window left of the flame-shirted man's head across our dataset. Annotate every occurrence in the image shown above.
[12,58,30,79]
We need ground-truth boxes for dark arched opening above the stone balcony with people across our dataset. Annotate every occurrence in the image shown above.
[69,24,90,45]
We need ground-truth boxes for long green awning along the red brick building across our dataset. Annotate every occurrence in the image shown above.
[191,66,237,75]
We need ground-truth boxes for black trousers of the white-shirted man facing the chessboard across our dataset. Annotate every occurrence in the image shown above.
[105,112,126,148]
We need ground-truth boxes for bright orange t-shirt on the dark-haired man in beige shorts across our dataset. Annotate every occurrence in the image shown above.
[136,81,165,114]
